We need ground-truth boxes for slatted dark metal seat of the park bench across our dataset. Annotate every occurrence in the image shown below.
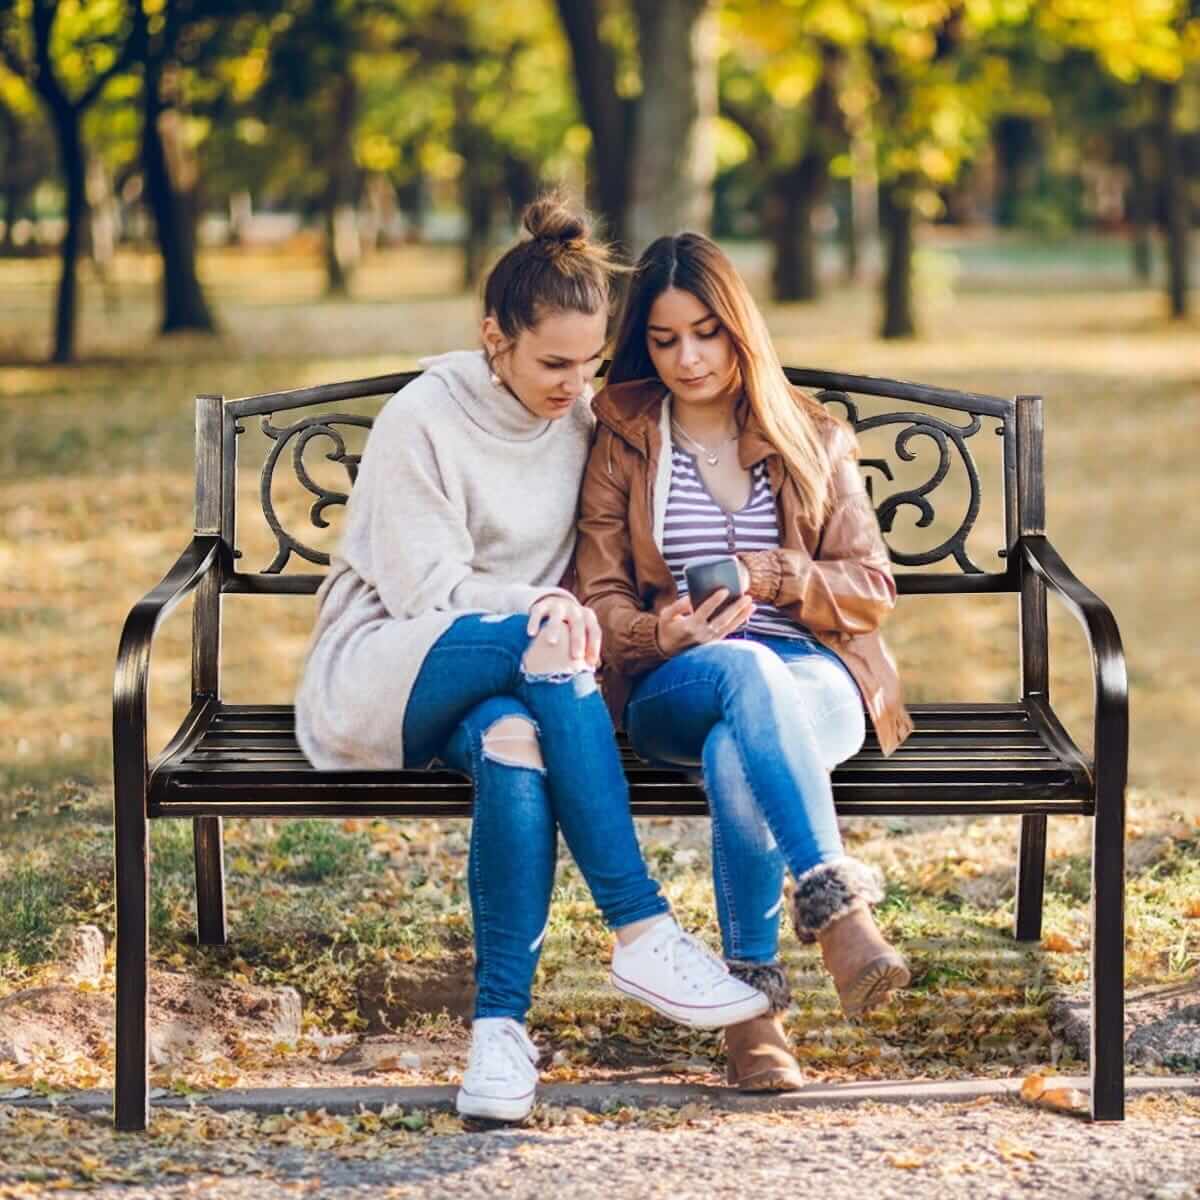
[150,702,1092,817]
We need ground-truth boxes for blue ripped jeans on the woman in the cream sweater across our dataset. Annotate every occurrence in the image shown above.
[404,613,668,1021]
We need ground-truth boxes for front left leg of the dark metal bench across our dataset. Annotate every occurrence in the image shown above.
[113,756,150,1129]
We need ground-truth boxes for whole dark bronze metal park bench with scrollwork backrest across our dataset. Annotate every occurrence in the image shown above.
[113,368,1128,1129]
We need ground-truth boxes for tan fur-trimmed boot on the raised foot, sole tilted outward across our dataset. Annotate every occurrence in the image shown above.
[792,858,910,1016]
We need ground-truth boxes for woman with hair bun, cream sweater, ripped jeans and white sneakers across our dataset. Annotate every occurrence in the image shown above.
[296,197,768,1120]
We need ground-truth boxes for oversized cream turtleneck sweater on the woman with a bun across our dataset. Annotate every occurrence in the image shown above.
[296,350,593,770]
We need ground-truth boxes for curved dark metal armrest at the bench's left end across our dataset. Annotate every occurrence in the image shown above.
[113,534,221,773]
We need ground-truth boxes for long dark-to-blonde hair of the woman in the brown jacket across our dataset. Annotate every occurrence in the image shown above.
[606,233,832,528]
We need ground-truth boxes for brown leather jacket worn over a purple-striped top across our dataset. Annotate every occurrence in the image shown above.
[575,379,912,754]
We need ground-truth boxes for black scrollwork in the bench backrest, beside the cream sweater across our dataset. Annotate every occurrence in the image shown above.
[259,413,372,575]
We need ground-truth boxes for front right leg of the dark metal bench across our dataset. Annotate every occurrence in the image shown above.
[1092,779,1124,1121]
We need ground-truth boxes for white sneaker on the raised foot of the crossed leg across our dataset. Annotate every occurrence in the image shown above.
[608,918,770,1030]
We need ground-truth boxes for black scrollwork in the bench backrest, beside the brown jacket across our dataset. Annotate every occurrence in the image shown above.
[817,391,985,575]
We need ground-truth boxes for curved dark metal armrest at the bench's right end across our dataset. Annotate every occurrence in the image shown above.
[1020,534,1129,799]
